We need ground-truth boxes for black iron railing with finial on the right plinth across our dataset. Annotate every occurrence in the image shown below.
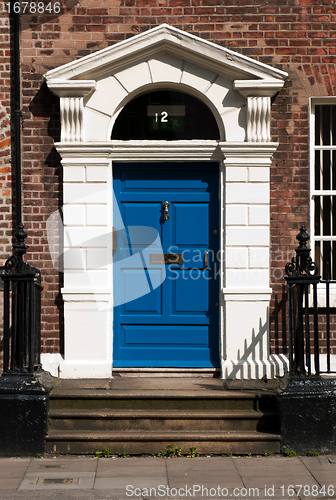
[285,226,334,376]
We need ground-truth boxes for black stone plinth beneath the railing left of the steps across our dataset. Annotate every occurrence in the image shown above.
[0,375,50,457]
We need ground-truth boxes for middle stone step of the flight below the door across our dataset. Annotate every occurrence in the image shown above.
[49,409,277,432]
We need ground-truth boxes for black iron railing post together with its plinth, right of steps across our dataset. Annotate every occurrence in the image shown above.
[277,226,336,455]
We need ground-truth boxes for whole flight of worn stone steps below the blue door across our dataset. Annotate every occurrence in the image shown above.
[47,376,280,455]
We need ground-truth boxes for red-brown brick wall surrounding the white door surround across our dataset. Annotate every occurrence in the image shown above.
[0,0,336,368]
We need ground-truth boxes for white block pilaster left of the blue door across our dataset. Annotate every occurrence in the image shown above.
[59,147,113,378]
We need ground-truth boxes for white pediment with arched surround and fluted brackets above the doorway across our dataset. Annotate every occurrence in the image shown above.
[44,24,287,142]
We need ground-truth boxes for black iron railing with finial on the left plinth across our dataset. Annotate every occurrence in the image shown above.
[1,224,42,375]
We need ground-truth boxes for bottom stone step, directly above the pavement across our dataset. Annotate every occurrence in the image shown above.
[47,430,280,455]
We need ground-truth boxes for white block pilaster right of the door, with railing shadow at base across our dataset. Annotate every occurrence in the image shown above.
[221,143,281,379]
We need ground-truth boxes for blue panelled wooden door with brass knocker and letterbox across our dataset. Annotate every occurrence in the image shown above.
[113,163,220,368]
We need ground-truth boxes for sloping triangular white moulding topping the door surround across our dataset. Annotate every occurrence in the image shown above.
[44,24,287,82]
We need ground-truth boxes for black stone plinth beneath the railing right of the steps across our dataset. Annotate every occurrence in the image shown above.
[277,377,336,455]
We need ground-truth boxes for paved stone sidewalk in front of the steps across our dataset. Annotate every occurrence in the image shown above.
[0,455,336,500]
